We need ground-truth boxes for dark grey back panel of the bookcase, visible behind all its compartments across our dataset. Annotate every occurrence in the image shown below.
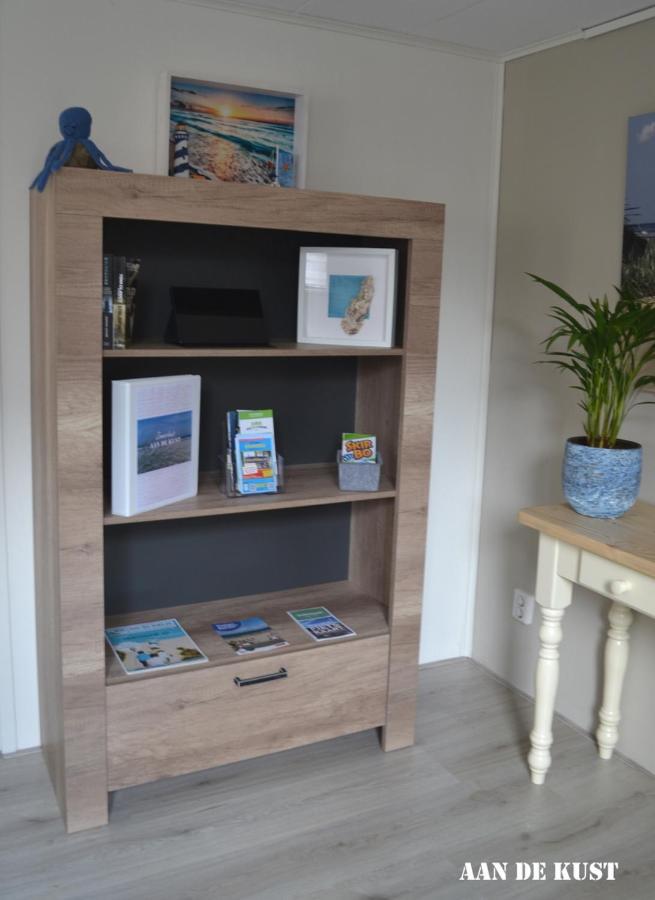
[104,219,394,613]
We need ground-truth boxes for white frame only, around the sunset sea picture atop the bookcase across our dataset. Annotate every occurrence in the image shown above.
[155,70,307,188]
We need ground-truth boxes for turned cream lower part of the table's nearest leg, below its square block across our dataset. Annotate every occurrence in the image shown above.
[528,607,564,784]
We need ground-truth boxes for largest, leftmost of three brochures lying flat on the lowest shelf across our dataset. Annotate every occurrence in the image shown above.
[105,619,207,675]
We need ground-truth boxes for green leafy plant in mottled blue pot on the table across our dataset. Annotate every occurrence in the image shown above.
[528,273,655,519]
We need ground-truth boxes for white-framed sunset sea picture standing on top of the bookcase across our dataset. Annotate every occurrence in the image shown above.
[157,74,307,187]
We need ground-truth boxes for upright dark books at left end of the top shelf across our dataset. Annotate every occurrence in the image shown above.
[102,254,141,350]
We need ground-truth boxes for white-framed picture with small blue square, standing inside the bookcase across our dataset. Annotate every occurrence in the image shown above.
[297,247,396,347]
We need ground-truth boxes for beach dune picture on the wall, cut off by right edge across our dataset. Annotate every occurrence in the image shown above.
[621,112,655,300]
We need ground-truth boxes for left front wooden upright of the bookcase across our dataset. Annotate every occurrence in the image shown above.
[55,212,108,832]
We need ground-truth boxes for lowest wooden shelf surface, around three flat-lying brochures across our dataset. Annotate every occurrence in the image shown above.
[106,581,389,685]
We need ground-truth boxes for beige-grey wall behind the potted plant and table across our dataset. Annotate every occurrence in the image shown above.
[474,22,655,770]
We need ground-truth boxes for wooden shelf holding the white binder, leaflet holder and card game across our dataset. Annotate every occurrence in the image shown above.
[104,463,396,526]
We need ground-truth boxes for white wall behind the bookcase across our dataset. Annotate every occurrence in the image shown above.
[0,0,500,751]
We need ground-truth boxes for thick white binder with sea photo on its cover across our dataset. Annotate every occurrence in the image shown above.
[111,375,200,516]
